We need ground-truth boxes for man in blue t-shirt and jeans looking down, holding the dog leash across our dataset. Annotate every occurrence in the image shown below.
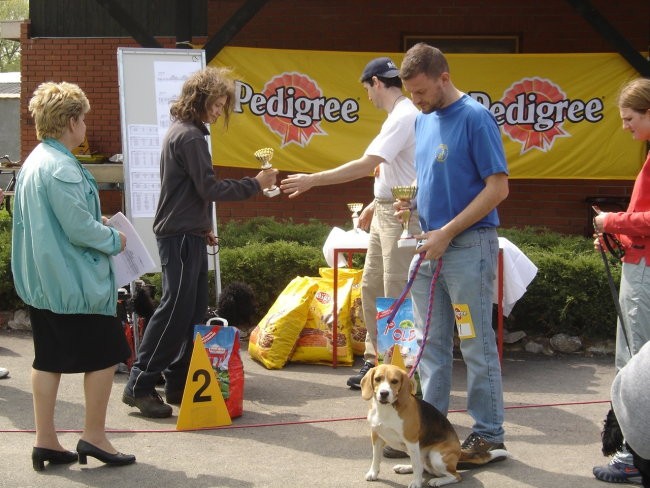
[400,43,508,468]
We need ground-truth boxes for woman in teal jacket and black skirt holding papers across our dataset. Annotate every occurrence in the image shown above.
[11,82,135,471]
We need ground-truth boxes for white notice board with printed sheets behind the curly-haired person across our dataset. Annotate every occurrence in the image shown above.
[117,47,205,271]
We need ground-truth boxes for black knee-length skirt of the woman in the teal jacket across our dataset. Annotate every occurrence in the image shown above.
[29,307,131,373]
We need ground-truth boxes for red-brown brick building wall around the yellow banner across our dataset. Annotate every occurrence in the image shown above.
[21,0,650,234]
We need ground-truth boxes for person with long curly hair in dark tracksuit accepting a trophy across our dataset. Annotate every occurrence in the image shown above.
[122,67,278,418]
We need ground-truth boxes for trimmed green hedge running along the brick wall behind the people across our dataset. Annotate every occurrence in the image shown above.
[0,212,620,339]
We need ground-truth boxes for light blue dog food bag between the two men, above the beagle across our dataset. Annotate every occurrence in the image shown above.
[375,297,422,368]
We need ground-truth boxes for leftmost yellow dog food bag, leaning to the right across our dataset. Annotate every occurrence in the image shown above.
[248,276,318,369]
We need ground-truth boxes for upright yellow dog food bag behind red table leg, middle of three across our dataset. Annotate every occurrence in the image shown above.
[289,278,354,366]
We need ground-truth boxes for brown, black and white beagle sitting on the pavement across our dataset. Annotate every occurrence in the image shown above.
[361,364,510,488]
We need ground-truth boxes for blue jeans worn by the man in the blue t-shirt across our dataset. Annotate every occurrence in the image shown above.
[411,228,504,442]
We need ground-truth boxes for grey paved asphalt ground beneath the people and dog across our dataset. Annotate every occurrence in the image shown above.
[0,330,614,488]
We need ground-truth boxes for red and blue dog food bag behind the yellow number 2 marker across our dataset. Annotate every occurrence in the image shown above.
[194,318,244,418]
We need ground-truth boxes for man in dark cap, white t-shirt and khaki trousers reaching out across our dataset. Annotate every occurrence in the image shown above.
[280,57,420,404]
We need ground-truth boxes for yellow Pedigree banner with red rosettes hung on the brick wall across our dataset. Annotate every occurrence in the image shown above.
[210,47,645,179]
